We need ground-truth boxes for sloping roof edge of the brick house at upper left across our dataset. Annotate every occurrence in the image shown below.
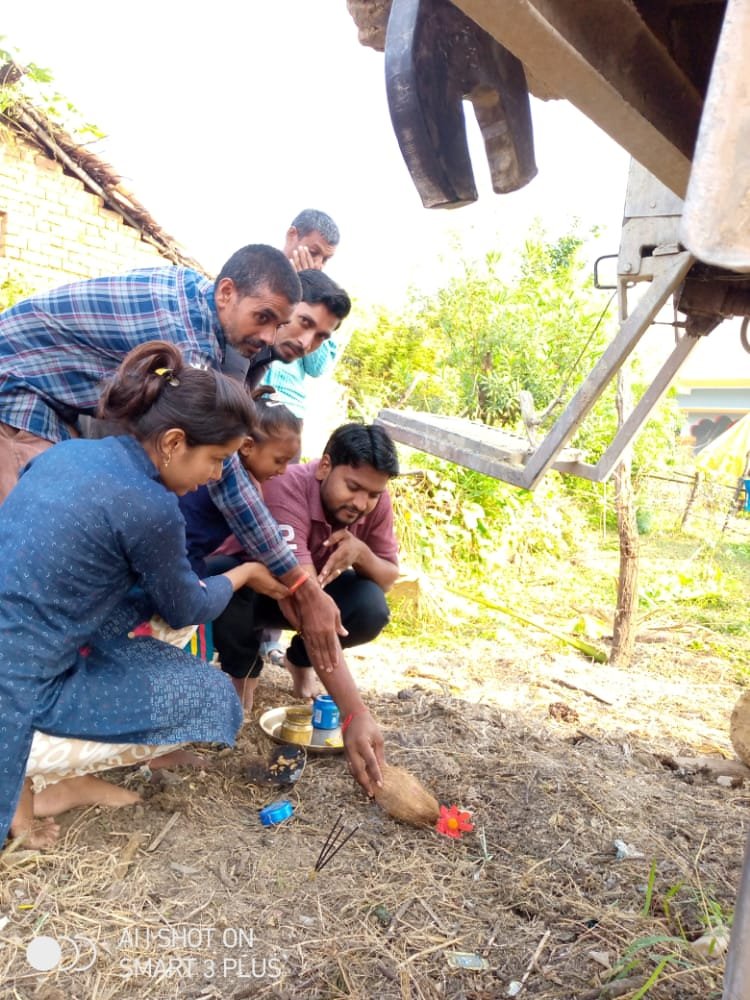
[0,63,207,274]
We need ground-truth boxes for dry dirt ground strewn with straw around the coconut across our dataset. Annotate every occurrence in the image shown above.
[0,623,748,1000]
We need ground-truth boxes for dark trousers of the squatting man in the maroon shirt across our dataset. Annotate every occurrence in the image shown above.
[212,567,390,677]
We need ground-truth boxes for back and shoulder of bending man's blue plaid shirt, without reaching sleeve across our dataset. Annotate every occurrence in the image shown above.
[0,267,223,441]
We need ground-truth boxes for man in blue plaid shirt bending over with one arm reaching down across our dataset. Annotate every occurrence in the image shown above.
[0,244,350,670]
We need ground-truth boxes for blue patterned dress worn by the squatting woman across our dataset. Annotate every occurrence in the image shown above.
[0,436,242,845]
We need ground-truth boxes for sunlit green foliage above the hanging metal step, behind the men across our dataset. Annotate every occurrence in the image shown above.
[339,236,616,427]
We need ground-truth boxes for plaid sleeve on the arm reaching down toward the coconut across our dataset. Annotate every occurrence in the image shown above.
[208,455,297,576]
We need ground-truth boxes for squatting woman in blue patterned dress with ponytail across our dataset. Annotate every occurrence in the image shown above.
[0,341,288,846]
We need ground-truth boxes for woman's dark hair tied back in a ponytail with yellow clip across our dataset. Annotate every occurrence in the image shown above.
[96,340,254,448]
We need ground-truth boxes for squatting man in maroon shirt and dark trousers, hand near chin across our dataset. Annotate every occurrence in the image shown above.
[214,424,399,712]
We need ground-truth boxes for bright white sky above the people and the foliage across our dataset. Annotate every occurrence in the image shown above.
[0,0,628,308]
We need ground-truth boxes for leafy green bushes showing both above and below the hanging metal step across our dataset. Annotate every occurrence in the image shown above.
[338,233,676,576]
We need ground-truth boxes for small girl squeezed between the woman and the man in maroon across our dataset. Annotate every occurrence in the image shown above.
[180,385,302,712]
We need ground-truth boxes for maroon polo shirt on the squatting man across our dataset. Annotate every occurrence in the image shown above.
[263,459,398,573]
